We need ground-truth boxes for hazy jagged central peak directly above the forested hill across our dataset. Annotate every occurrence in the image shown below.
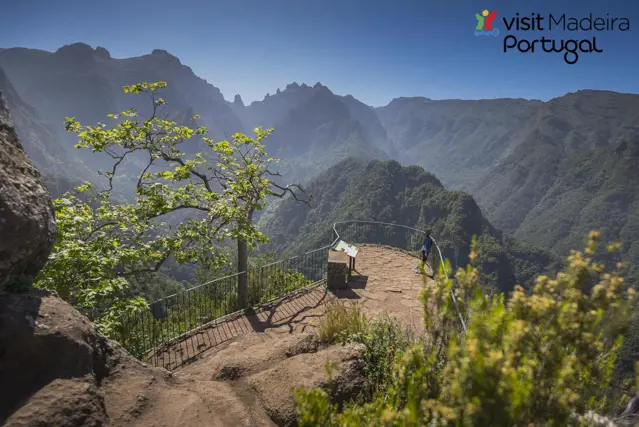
[231,83,392,179]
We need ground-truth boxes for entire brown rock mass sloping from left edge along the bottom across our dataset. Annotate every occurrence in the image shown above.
[0,291,272,427]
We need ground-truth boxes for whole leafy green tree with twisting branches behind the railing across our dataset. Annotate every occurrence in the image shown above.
[36,82,310,335]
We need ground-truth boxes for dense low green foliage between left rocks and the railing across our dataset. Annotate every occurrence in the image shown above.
[34,189,149,337]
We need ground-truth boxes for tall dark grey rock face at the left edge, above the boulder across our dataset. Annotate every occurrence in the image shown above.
[0,92,55,293]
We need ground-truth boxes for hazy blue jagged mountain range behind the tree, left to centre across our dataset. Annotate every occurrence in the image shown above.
[0,43,390,189]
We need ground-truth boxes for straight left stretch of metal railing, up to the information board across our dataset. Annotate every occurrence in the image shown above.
[116,246,329,364]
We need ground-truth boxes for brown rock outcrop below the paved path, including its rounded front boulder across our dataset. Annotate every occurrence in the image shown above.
[176,333,366,427]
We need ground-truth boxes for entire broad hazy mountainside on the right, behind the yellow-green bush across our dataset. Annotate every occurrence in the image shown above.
[377,90,639,275]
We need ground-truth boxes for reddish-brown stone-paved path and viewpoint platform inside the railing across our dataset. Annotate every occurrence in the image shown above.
[154,246,431,370]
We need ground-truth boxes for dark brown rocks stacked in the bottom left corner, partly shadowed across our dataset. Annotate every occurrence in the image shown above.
[0,292,109,426]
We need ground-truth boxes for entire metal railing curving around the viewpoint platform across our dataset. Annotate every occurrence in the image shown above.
[116,220,466,364]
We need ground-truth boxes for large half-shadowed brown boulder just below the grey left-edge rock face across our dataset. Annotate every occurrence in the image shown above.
[0,291,113,425]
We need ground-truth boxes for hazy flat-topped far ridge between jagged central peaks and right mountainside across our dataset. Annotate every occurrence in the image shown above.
[376,98,543,188]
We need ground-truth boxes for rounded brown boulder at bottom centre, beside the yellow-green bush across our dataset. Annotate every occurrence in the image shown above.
[248,344,366,426]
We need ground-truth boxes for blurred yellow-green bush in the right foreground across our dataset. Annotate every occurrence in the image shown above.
[297,232,634,427]
